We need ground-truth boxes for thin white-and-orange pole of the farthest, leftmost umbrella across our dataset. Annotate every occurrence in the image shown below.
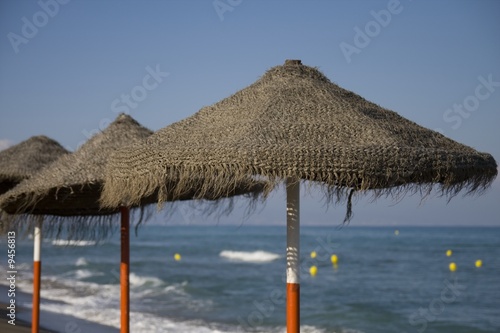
[31,216,43,333]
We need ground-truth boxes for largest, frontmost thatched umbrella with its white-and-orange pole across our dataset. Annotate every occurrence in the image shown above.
[103,60,497,332]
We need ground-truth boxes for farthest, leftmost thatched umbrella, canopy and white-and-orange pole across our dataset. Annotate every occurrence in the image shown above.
[0,136,69,332]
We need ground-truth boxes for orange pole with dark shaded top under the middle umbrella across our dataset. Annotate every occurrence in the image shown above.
[120,206,130,333]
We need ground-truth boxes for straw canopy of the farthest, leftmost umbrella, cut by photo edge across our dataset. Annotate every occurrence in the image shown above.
[0,135,69,194]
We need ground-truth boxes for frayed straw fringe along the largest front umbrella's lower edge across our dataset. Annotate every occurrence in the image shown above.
[101,146,494,222]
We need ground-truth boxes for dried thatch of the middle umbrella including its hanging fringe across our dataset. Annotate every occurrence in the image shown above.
[0,114,262,238]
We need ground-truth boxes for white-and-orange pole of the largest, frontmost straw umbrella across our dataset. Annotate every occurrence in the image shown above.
[286,178,300,333]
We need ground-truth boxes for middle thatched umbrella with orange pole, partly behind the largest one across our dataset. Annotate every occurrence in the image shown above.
[0,114,262,332]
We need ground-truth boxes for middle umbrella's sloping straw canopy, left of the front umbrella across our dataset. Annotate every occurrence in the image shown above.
[0,114,152,216]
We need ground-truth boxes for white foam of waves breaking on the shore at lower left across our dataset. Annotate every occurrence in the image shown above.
[0,270,336,333]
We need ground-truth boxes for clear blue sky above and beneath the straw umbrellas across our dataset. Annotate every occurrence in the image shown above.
[0,0,500,226]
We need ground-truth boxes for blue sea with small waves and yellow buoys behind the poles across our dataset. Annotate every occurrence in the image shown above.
[0,223,500,333]
